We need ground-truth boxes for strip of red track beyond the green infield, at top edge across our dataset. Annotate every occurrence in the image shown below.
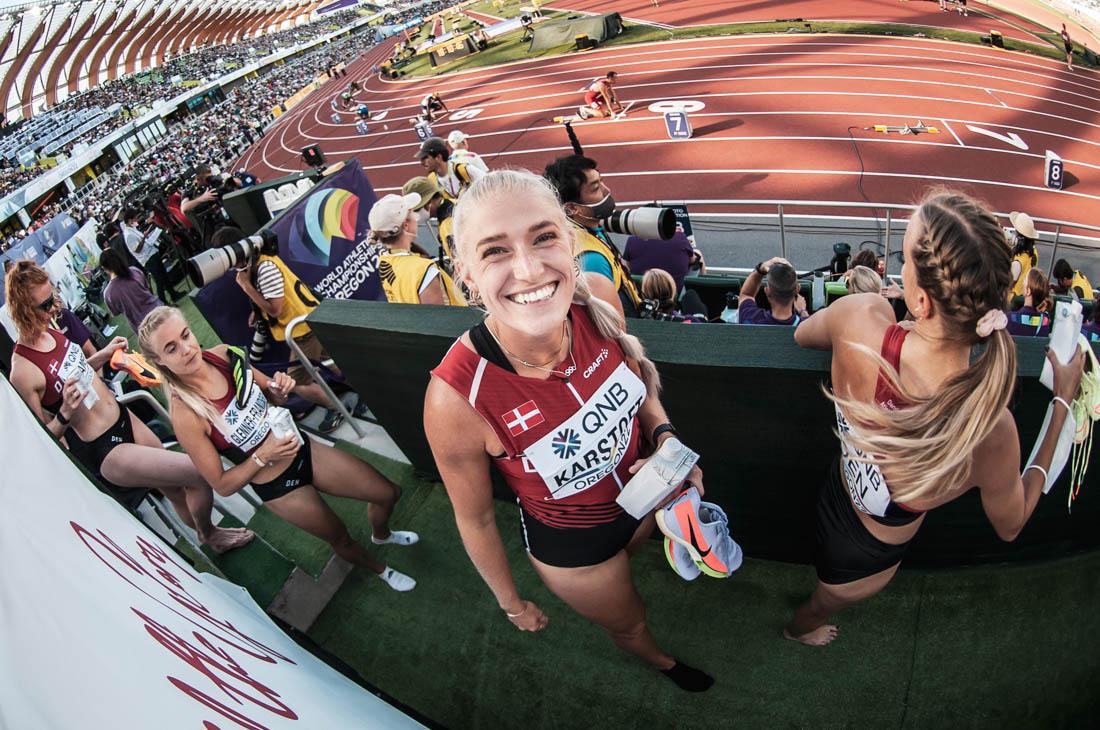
[550,0,1046,42]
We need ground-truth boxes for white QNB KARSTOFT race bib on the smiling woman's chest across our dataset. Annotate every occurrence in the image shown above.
[524,363,646,499]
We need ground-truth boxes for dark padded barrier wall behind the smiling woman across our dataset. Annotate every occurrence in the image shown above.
[309,300,1100,567]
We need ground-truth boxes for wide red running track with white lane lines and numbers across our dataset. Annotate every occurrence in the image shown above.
[234,35,1100,234]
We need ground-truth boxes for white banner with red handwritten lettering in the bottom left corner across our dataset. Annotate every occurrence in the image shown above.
[0,377,421,730]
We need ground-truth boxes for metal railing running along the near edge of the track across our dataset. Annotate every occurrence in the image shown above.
[619,199,1100,275]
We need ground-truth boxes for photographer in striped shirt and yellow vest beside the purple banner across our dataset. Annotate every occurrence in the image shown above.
[210,225,343,433]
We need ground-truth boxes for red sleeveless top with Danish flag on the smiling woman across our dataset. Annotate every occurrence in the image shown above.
[431,305,646,529]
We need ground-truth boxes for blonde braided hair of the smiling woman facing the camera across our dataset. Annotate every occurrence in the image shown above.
[453,169,661,396]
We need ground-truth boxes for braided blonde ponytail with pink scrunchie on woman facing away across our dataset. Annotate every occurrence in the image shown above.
[829,189,1016,501]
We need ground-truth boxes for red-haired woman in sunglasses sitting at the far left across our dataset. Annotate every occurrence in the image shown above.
[6,261,254,553]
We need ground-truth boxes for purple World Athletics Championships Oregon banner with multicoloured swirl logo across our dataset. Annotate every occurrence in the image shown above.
[195,159,386,354]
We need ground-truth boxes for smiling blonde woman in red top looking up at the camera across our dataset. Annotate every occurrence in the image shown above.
[425,170,713,692]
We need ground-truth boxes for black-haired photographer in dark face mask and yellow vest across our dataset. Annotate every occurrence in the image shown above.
[543,155,641,317]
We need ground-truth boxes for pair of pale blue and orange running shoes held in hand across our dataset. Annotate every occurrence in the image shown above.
[657,486,744,580]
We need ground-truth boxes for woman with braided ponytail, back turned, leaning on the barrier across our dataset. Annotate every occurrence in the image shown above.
[784,191,1085,645]
